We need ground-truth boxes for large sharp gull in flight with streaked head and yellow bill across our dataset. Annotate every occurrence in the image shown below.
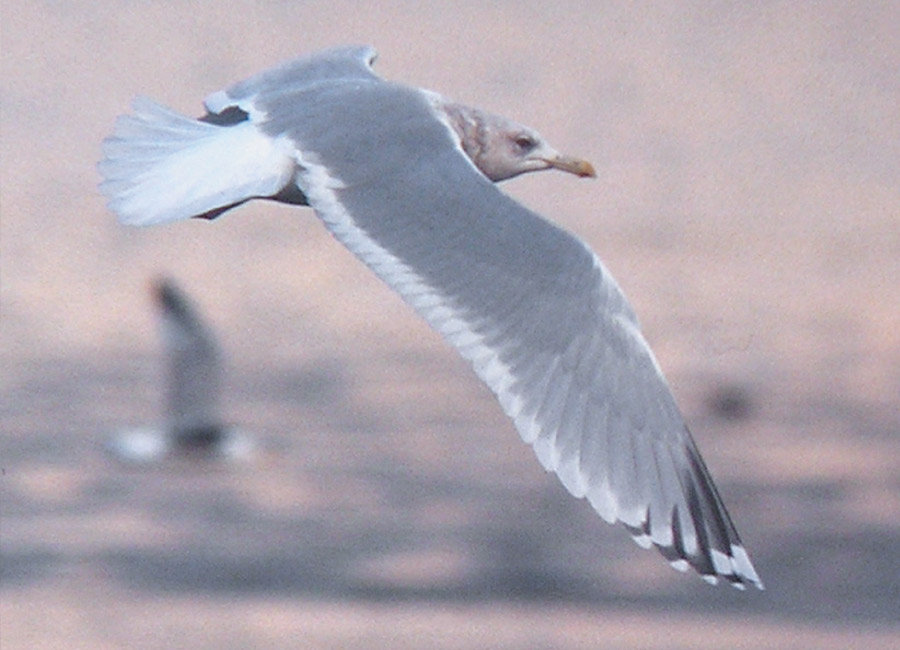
[99,47,763,589]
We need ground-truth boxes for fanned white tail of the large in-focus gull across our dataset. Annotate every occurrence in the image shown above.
[98,97,296,226]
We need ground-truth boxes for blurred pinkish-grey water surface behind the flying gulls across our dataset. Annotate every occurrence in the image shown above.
[0,0,900,650]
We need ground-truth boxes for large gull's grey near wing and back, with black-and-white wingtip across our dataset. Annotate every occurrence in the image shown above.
[255,80,762,588]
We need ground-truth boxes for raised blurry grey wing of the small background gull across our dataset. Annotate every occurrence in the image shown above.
[155,280,222,434]
